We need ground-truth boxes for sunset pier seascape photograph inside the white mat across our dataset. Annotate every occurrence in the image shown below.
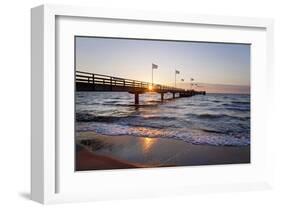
[74,36,251,171]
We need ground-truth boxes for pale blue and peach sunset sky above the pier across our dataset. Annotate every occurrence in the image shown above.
[75,37,250,93]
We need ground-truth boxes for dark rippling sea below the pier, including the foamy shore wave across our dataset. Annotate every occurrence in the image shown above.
[75,92,250,146]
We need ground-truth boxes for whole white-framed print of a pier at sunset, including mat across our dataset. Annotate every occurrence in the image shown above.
[31,5,273,203]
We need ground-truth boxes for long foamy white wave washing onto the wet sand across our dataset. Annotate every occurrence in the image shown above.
[77,123,250,146]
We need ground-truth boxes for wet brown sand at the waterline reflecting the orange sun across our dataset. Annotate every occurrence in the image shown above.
[76,132,250,171]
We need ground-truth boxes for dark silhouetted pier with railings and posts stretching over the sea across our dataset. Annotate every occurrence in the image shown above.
[75,71,206,105]
